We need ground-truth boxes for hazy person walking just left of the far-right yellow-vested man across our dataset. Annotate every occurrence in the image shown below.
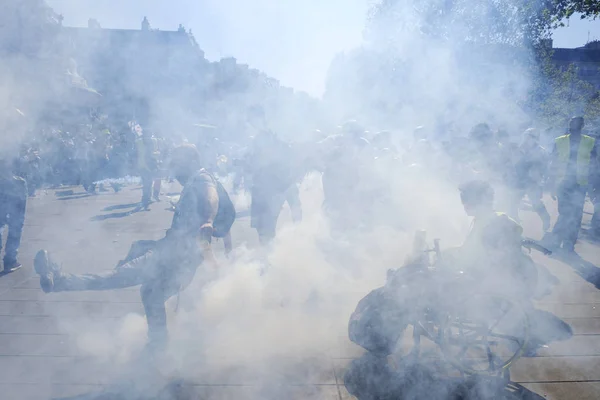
[512,128,550,232]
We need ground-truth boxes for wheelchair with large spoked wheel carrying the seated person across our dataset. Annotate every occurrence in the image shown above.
[383,231,550,379]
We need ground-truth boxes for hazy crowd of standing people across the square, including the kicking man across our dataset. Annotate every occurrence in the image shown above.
[0,103,600,360]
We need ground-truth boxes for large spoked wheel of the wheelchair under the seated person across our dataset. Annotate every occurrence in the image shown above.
[440,294,530,375]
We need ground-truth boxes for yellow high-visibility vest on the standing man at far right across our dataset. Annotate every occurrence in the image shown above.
[554,134,596,186]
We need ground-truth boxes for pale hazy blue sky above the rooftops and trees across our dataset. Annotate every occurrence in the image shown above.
[47,0,600,95]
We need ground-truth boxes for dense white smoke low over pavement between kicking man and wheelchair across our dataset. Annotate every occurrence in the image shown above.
[63,175,418,385]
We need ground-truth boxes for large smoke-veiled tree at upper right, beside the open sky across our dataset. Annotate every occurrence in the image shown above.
[326,0,598,131]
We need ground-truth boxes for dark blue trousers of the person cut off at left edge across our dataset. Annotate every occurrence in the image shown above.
[0,195,27,265]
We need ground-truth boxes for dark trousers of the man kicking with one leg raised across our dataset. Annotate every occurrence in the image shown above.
[49,238,202,346]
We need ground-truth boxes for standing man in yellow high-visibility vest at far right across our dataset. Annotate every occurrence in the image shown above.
[545,117,598,253]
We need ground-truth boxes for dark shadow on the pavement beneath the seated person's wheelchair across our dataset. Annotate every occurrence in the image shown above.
[344,353,544,400]
